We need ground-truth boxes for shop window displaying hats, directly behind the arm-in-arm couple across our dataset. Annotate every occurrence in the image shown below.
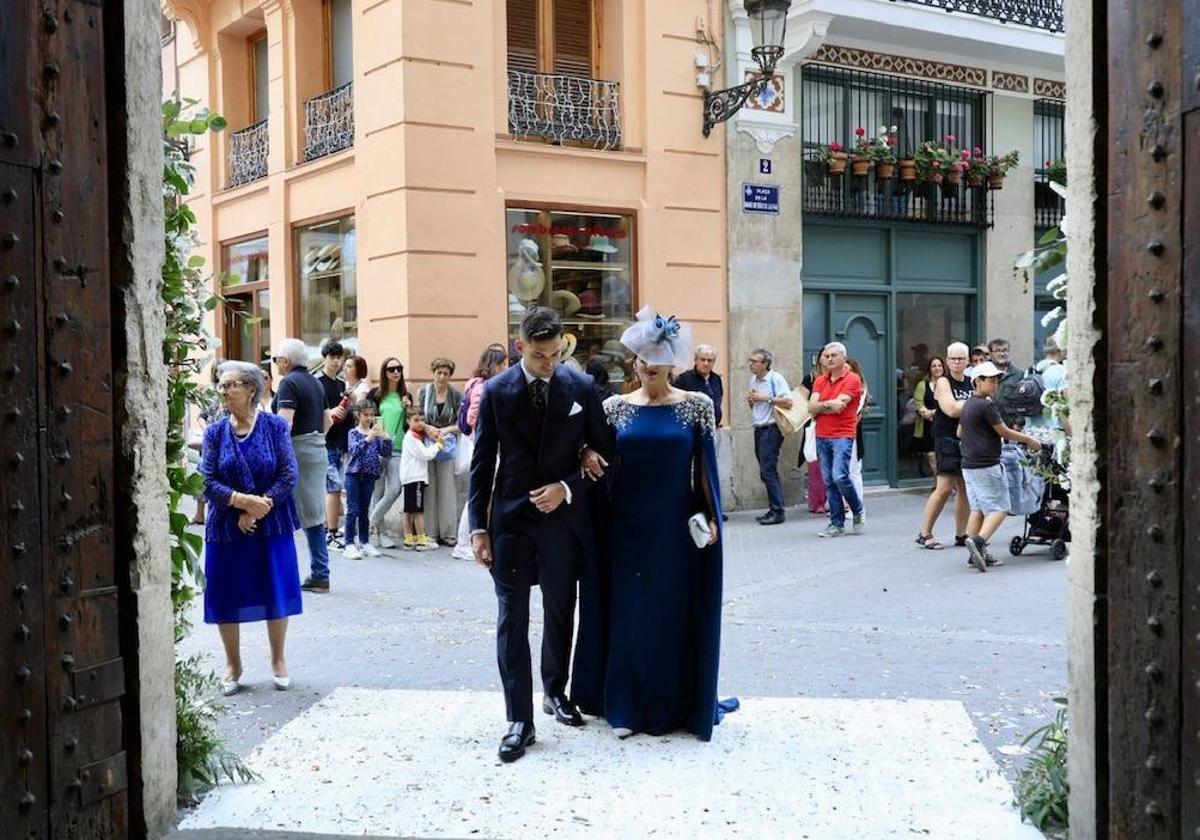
[506,208,636,390]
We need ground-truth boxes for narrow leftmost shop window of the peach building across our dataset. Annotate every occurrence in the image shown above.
[220,236,271,361]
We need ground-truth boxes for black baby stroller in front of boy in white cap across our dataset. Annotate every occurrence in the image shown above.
[1000,444,1070,560]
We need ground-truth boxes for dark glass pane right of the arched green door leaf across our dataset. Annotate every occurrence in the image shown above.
[895,293,974,480]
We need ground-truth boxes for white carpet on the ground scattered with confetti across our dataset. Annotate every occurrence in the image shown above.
[180,689,1042,840]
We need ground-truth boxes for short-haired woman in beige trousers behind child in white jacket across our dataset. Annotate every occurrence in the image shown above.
[416,358,462,546]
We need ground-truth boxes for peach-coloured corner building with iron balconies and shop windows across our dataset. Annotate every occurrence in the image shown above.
[163,0,728,398]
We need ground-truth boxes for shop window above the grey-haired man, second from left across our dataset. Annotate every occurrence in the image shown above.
[295,216,359,358]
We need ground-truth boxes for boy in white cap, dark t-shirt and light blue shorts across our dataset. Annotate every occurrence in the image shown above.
[958,361,1042,571]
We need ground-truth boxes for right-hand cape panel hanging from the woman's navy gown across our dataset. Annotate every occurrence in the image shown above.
[689,394,725,740]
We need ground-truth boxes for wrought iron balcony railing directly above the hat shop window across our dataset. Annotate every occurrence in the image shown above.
[509,70,620,149]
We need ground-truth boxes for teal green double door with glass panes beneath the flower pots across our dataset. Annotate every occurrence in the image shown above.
[803,218,982,486]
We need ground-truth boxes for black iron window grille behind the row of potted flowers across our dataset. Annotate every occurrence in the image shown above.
[800,64,992,228]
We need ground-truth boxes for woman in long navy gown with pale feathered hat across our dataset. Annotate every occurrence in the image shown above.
[571,308,721,740]
